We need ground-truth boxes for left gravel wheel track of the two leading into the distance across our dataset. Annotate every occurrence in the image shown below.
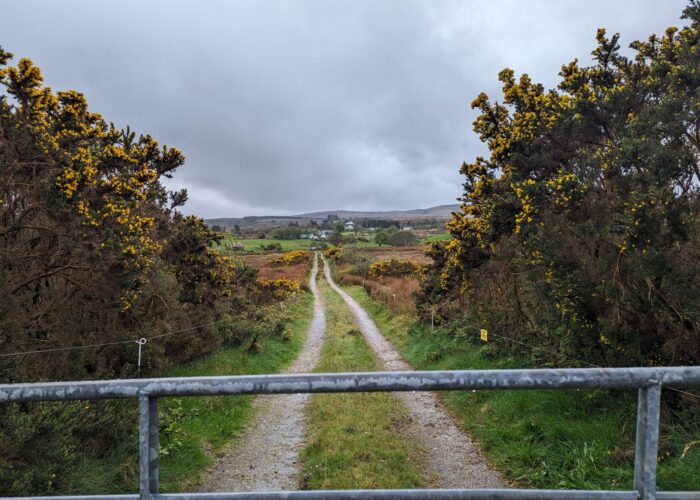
[198,255,326,492]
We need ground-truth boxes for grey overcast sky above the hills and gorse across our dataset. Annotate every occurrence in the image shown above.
[0,0,686,217]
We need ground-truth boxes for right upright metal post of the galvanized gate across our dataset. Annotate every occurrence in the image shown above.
[634,381,661,500]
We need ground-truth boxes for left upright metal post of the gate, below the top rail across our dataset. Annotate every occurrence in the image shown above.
[139,393,159,500]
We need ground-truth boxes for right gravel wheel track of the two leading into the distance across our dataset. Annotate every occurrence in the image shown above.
[323,258,507,488]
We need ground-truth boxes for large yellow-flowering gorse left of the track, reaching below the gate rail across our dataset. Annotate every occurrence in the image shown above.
[0,49,274,495]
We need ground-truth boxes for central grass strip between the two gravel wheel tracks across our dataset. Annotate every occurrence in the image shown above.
[302,281,421,489]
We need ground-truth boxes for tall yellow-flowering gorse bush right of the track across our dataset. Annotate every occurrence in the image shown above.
[419,2,700,366]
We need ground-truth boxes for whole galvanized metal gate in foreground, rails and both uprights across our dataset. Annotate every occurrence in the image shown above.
[0,366,700,500]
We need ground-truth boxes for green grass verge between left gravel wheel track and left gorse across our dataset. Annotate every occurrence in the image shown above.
[161,293,313,492]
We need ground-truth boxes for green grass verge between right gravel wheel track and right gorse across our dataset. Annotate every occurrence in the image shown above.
[346,286,700,490]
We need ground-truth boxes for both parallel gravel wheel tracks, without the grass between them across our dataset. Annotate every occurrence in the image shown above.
[200,257,506,491]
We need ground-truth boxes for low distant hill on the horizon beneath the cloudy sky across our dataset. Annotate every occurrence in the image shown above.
[206,204,459,228]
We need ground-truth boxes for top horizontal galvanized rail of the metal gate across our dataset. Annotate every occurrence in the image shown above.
[0,366,700,403]
